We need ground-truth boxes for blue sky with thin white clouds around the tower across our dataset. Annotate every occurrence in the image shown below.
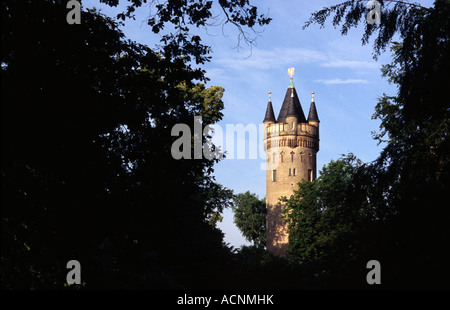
[83,0,432,247]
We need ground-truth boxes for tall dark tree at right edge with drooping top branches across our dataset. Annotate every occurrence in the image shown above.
[305,0,450,287]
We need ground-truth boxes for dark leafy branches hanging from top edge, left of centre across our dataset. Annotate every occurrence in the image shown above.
[100,0,271,64]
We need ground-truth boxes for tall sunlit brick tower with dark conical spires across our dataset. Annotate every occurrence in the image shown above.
[263,68,319,256]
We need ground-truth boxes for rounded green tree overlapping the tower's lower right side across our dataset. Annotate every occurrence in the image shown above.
[281,153,377,287]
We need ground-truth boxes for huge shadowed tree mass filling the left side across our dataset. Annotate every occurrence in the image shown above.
[1,1,246,289]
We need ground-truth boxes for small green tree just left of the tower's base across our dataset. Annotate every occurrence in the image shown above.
[233,191,267,247]
